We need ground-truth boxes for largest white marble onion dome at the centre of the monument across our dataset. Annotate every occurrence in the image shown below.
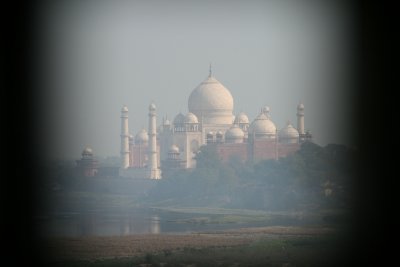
[188,75,233,124]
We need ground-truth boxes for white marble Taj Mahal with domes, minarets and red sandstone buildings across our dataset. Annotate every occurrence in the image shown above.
[119,67,312,179]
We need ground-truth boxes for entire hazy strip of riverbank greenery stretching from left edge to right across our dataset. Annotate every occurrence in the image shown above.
[41,142,358,214]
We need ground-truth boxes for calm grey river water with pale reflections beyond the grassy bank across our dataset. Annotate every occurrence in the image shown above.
[36,209,310,237]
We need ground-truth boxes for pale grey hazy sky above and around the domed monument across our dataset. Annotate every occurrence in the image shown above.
[37,0,353,158]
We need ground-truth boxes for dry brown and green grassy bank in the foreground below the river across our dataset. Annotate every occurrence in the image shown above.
[39,227,345,267]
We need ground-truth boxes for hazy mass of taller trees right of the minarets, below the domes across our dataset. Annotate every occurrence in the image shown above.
[148,142,356,210]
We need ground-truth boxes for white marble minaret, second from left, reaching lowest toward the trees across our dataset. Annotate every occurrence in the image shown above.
[148,103,161,179]
